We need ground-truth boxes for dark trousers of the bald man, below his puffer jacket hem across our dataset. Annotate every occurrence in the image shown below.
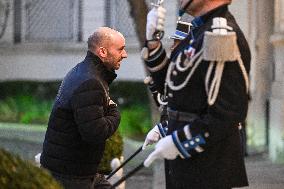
[51,173,111,189]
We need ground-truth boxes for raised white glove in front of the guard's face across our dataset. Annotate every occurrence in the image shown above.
[146,6,166,40]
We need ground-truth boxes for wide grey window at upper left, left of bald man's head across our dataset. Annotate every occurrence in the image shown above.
[15,0,81,42]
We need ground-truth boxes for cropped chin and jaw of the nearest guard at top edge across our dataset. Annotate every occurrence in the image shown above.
[180,0,232,16]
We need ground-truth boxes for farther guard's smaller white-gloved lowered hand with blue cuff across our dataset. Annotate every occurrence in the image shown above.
[142,121,168,150]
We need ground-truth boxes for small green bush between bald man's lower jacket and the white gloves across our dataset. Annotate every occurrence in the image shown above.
[98,131,123,174]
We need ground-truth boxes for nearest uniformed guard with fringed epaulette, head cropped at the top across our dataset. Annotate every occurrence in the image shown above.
[142,0,251,189]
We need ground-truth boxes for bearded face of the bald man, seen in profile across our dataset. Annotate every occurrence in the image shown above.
[105,34,127,70]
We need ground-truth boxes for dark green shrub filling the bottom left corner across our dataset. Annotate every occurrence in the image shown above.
[0,149,62,189]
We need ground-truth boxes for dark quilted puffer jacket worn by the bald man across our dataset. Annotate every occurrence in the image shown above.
[40,52,120,176]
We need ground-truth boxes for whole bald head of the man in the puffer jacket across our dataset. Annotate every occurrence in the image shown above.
[88,27,127,70]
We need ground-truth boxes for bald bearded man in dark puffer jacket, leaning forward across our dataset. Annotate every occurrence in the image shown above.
[40,27,127,189]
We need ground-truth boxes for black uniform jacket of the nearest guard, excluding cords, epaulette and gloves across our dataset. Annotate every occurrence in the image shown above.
[145,5,251,189]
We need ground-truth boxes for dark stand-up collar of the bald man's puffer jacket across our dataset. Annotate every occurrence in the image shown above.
[85,51,117,84]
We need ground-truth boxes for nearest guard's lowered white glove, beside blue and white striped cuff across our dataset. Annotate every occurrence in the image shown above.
[144,135,183,167]
